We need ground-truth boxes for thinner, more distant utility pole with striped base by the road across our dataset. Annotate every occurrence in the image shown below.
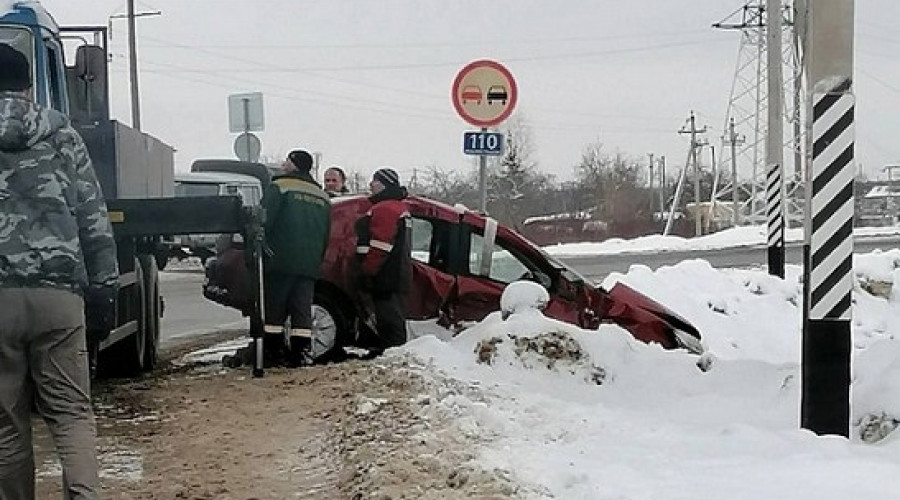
[766,0,784,279]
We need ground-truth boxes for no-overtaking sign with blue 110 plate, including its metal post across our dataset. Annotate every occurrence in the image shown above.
[450,59,519,213]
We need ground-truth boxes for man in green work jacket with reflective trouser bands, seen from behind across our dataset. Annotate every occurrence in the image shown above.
[263,150,331,366]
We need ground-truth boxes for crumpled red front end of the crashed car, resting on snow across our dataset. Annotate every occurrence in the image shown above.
[601,283,703,354]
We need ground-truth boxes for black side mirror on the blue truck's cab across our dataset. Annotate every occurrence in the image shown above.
[66,45,109,124]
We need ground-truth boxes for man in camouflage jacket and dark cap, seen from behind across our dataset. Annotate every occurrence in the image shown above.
[0,44,118,500]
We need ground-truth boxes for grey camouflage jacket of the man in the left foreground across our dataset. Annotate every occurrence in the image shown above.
[0,92,119,293]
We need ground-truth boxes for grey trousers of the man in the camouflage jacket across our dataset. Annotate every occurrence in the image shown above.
[0,288,100,500]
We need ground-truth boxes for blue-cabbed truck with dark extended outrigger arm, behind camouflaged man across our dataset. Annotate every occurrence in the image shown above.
[0,0,263,376]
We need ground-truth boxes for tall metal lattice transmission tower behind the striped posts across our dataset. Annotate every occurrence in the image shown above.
[713,0,804,224]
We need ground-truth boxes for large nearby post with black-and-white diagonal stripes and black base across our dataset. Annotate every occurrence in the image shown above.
[800,0,855,437]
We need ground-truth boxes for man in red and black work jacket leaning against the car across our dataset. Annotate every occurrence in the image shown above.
[356,168,412,353]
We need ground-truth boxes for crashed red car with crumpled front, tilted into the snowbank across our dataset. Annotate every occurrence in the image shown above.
[204,196,702,358]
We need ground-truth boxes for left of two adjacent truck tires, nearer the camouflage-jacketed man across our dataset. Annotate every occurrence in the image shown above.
[98,259,147,377]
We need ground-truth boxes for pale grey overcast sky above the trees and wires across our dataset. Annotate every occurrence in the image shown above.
[42,0,900,181]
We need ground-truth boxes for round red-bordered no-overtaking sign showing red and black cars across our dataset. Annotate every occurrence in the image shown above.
[450,59,519,127]
